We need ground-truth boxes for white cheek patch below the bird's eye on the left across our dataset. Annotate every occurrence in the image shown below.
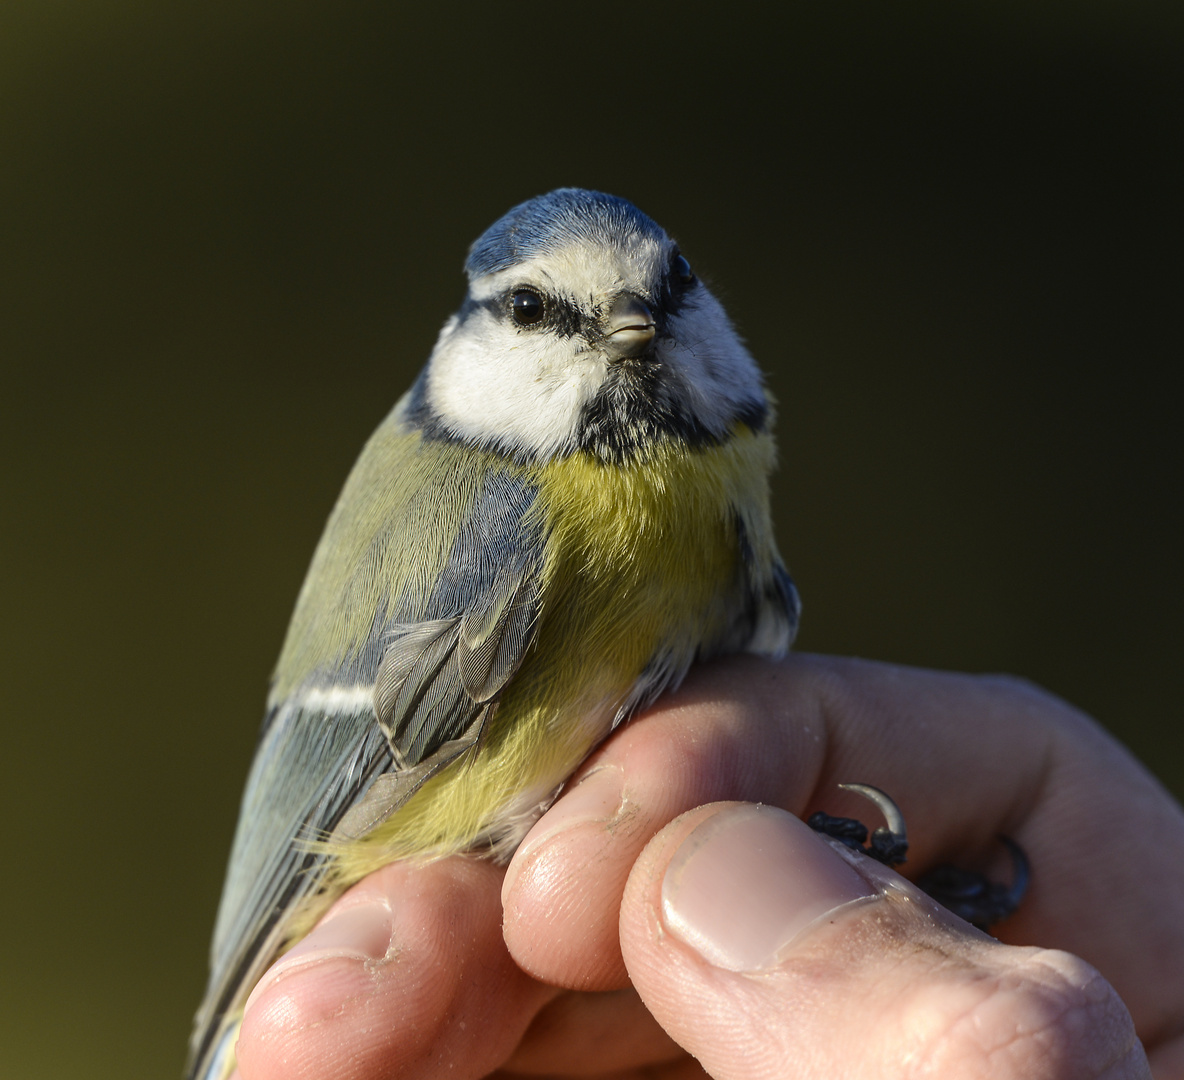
[427,315,607,456]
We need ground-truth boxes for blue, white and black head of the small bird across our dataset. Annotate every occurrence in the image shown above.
[412,188,767,462]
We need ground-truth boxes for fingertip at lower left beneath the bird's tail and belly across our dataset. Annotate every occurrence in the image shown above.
[237,859,555,1080]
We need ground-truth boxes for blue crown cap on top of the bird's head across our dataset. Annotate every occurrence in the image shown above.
[464,187,665,279]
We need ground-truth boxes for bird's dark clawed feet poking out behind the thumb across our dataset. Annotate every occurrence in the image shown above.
[806,784,1031,930]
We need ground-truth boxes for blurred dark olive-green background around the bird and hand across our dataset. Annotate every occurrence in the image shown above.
[0,0,1184,1078]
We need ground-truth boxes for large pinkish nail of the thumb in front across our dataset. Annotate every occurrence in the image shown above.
[662,805,879,971]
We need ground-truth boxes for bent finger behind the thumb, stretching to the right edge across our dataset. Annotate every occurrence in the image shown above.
[503,655,1184,1040]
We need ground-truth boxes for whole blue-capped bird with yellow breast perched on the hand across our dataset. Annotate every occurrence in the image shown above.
[187,188,798,1080]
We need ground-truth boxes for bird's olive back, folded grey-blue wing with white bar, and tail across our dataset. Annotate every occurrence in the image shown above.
[187,406,542,1078]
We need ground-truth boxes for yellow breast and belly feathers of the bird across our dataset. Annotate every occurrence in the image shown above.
[324,419,776,885]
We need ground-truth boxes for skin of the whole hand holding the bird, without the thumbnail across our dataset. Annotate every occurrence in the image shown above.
[228,655,1184,1080]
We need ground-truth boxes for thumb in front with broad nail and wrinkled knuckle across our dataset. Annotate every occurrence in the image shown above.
[620,803,1151,1080]
